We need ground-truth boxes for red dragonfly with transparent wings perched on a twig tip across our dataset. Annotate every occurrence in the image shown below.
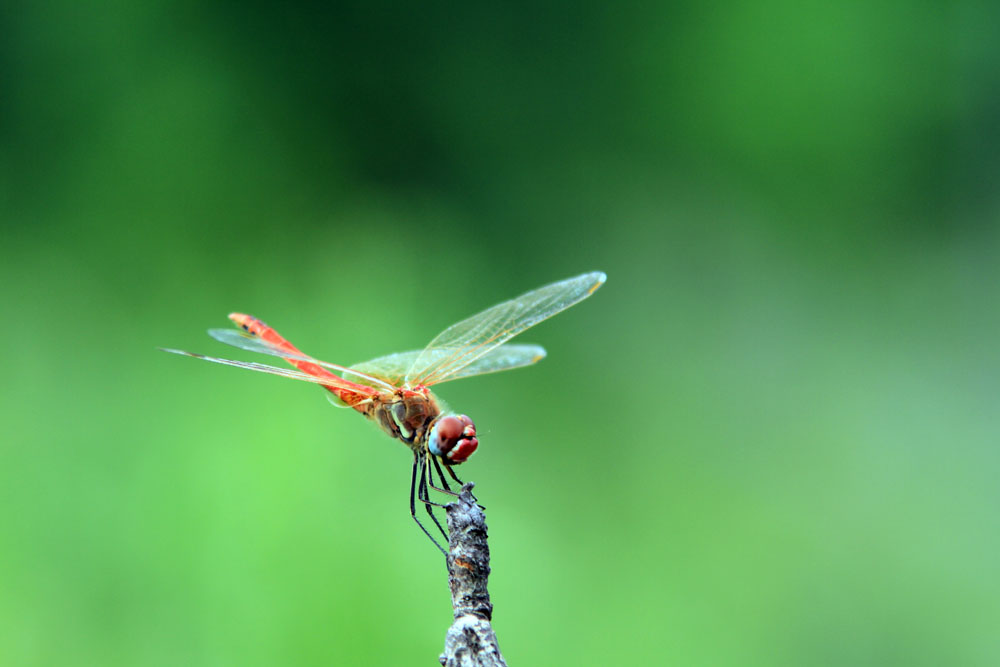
[160,271,607,553]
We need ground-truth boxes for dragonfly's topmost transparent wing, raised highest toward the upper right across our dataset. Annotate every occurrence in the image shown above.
[404,271,607,386]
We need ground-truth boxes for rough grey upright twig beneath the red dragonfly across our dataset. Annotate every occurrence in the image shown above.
[440,482,507,667]
